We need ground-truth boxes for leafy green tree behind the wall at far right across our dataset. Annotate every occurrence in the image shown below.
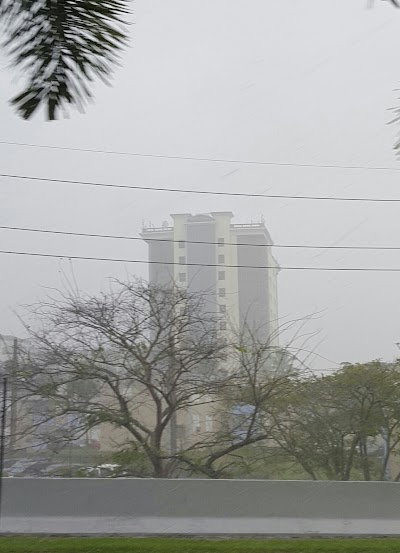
[268,361,400,480]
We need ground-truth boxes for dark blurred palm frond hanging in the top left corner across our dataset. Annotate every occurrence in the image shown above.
[0,0,128,120]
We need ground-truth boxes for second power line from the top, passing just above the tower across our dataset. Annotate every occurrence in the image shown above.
[0,173,400,203]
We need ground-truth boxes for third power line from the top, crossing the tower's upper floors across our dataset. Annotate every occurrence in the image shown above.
[0,225,400,251]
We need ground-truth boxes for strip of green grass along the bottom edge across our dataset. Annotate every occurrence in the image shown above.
[0,536,400,553]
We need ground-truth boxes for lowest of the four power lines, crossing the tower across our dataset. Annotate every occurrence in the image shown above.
[0,250,400,270]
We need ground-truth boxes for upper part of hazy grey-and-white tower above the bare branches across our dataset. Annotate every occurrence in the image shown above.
[141,211,279,346]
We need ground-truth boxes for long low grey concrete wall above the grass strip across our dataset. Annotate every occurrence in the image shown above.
[0,478,400,535]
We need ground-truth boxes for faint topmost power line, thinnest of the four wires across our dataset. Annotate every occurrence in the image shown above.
[0,140,400,171]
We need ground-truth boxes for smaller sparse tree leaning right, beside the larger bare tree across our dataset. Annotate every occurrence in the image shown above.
[173,326,300,478]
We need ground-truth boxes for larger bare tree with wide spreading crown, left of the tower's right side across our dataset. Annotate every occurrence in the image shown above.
[14,282,227,477]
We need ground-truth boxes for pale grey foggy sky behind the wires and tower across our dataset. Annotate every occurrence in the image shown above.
[0,0,400,367]
